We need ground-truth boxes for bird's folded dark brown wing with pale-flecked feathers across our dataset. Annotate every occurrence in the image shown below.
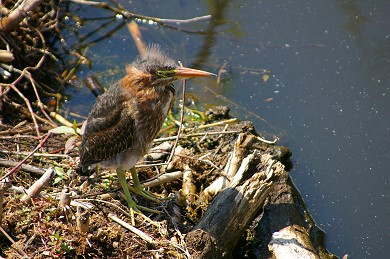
[79,84,136,167]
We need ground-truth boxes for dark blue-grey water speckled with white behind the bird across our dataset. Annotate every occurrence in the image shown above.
[66,0,390,258]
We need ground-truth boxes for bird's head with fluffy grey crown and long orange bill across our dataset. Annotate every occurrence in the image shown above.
[127,45,215,87]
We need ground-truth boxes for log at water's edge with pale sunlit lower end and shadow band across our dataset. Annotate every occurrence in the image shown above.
[253,168,337,258]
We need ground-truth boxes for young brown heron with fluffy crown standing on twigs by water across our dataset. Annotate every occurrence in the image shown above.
[79,45,214,225]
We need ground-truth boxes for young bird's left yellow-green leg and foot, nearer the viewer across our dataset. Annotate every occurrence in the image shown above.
[116,167,160,226]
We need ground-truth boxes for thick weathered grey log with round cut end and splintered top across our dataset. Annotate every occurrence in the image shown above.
[186,155,284,258]
